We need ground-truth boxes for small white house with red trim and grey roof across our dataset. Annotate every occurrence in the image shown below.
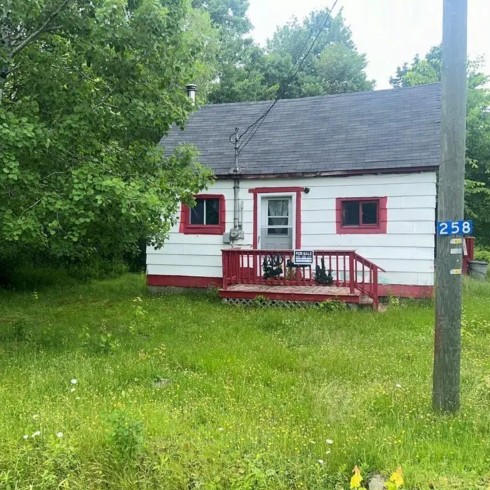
[147,84,440,302]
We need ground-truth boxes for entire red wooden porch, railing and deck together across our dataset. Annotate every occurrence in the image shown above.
[219,248,382,309]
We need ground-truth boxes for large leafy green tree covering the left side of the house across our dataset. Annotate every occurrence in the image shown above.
[0,0,213,259]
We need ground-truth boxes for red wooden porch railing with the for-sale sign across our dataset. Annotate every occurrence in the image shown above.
[222,249,383,306]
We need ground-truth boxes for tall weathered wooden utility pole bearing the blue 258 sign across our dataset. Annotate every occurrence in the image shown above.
[432,0,468,413]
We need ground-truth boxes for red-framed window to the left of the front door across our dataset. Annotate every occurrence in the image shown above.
[180,194,226,235]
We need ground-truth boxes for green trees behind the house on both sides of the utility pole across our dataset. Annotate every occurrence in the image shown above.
[390,46,490,246]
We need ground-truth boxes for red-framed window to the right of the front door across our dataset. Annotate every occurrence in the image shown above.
[337,197,387,233]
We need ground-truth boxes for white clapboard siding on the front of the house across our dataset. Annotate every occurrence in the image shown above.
[147,172,436,285]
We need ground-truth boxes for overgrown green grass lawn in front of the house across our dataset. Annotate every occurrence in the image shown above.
[0,275,490,490]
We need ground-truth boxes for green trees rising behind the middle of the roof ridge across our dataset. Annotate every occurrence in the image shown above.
[194,0,374,103]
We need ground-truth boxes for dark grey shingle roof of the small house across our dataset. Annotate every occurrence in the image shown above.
[161,84,441,176]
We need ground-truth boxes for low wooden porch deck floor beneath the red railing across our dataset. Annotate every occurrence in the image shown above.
[219,284,373,304]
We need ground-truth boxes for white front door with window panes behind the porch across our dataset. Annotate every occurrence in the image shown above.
[259,196,294,250]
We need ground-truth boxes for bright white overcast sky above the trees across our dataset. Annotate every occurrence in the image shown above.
[249,0,490,89]
